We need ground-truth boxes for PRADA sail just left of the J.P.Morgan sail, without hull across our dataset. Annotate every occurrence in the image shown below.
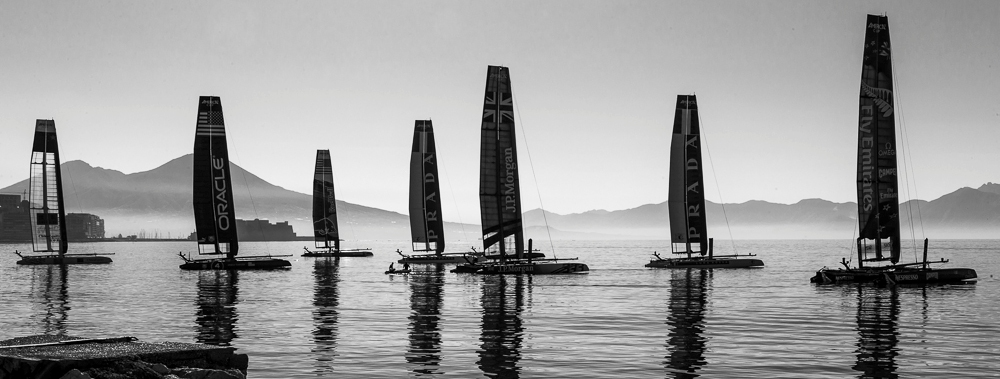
[410,120,444,254]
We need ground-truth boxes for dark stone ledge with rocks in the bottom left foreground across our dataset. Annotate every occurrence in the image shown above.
[0,335,249,379]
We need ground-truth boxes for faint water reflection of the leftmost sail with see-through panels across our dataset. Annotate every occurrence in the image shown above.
[32,265,70,335]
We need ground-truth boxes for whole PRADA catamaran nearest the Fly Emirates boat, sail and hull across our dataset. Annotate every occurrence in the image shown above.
[646,95,764,268]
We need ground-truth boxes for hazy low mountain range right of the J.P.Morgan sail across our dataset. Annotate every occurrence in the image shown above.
[524,188,1000,239]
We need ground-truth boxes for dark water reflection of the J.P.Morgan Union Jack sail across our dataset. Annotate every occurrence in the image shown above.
[476,274,531,378]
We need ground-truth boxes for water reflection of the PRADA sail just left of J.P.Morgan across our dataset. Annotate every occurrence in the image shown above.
[406,264,445,376]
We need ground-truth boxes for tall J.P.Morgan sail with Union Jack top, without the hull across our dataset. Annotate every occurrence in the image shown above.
[479,66,524,256]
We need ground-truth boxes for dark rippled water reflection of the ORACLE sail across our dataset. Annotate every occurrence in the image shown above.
[195,270,239,346]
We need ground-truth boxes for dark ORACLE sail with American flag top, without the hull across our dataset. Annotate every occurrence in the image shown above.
[192,96,239,257]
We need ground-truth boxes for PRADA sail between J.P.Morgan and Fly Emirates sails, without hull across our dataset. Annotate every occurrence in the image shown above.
[667,95,708,254]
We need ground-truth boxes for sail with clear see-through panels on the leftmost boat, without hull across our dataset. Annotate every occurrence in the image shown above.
[28,120,66,255]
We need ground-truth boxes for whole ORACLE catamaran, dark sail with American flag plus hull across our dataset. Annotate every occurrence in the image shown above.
[180,96,292,270]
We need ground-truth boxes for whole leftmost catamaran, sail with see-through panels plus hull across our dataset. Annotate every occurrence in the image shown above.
[14,120,111,265]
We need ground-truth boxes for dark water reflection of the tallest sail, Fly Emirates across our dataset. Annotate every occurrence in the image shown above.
[852,285,899,378]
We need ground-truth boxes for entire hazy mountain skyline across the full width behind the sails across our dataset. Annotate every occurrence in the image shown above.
[0,155,1000,240]
